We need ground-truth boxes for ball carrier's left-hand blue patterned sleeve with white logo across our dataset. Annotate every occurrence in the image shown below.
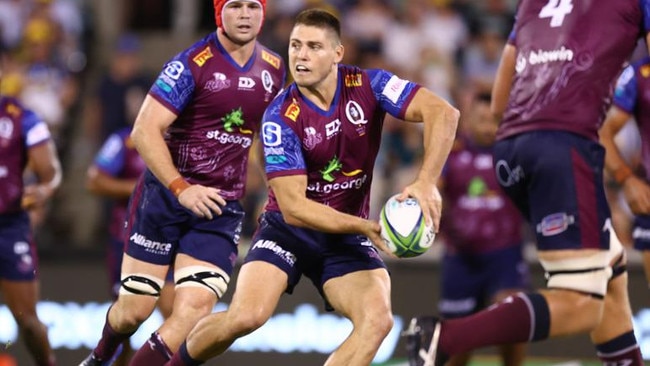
[262,99,307,178]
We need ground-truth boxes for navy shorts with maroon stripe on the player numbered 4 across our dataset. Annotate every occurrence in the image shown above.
[494,131,610,250]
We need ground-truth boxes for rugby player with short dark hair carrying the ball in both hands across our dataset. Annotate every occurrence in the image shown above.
[167,9,459,366]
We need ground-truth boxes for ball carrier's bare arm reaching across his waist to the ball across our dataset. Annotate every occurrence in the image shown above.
[269,175,390,253]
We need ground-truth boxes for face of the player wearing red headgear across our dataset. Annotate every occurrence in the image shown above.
[222,1,264,43]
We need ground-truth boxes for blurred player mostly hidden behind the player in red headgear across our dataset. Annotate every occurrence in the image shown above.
[86,123,174,366]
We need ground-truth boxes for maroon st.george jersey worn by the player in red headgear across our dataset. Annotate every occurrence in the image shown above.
[149,33,285,200]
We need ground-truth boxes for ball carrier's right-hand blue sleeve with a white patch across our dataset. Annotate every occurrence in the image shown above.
[366,69,420,119]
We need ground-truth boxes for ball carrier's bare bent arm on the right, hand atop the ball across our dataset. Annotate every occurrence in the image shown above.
[400,88,460,231]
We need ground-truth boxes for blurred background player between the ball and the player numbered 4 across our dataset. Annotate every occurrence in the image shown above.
[438,93,530,366]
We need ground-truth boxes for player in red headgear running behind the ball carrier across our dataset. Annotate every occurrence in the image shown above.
[82,0,285,366]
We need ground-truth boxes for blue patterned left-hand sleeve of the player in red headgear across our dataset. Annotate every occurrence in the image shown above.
[149,51,195,114]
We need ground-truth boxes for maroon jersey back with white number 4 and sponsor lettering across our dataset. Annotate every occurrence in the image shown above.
[497,0,646,140]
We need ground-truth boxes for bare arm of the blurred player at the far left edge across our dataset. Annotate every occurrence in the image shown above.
[22,140,62,209]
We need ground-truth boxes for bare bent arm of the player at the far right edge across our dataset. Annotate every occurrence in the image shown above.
[600,106,650,214]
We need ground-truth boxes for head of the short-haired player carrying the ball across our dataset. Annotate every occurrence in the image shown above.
[289,24,343,87]
